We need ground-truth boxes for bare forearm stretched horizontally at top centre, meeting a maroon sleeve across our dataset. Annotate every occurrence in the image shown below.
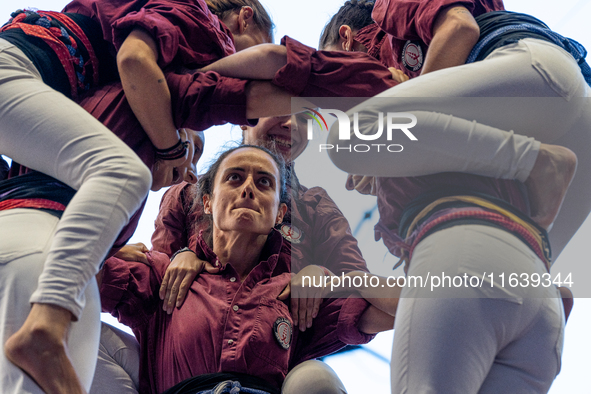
[200,44,287,80]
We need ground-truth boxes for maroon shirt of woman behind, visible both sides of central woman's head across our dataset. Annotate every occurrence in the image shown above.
[152,177,368,274]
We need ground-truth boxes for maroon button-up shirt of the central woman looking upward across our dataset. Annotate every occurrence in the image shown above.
[101,232,373,393]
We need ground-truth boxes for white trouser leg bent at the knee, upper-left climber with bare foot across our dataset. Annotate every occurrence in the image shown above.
[0,39,151,317]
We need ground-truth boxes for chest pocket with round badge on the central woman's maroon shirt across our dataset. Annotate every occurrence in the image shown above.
[247,297,293,380]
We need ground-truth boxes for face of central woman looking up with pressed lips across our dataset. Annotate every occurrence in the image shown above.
[203,148,287,235]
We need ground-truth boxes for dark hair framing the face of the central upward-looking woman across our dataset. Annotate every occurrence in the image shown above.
[191,145,289,246]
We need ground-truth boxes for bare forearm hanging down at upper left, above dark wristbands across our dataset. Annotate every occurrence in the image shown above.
[117,30,179,149]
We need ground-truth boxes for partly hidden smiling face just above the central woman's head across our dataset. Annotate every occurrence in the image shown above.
[244,115,308,163]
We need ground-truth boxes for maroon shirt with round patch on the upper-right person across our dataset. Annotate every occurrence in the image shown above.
[372,0,505,78]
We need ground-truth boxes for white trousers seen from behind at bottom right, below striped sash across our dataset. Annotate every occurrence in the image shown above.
[391,225,564,394]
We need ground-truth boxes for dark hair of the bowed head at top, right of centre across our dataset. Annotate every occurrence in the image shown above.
[318,0,374,49]
